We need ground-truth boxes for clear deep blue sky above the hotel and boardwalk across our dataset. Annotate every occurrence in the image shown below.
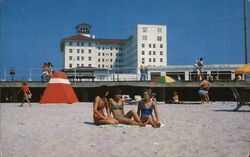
[0,0,250,68]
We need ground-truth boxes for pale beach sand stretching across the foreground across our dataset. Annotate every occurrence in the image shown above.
[0,102,250,157]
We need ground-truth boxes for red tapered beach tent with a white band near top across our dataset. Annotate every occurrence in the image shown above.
[40,71,79,104]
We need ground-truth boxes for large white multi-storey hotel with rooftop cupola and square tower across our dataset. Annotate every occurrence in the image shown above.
[61,23,167,73]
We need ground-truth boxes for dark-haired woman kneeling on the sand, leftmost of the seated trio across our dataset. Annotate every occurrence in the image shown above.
[93,86,118,125]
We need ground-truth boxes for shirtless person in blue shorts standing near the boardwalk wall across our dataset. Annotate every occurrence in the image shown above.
[198,79,211,103]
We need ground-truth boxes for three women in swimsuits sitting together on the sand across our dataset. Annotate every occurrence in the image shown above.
[93,86,161,128]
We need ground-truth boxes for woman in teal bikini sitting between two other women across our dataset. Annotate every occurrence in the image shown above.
[109,88,146,126]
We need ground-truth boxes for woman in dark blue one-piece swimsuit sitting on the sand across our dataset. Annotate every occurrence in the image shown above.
[137,89,161,128]
